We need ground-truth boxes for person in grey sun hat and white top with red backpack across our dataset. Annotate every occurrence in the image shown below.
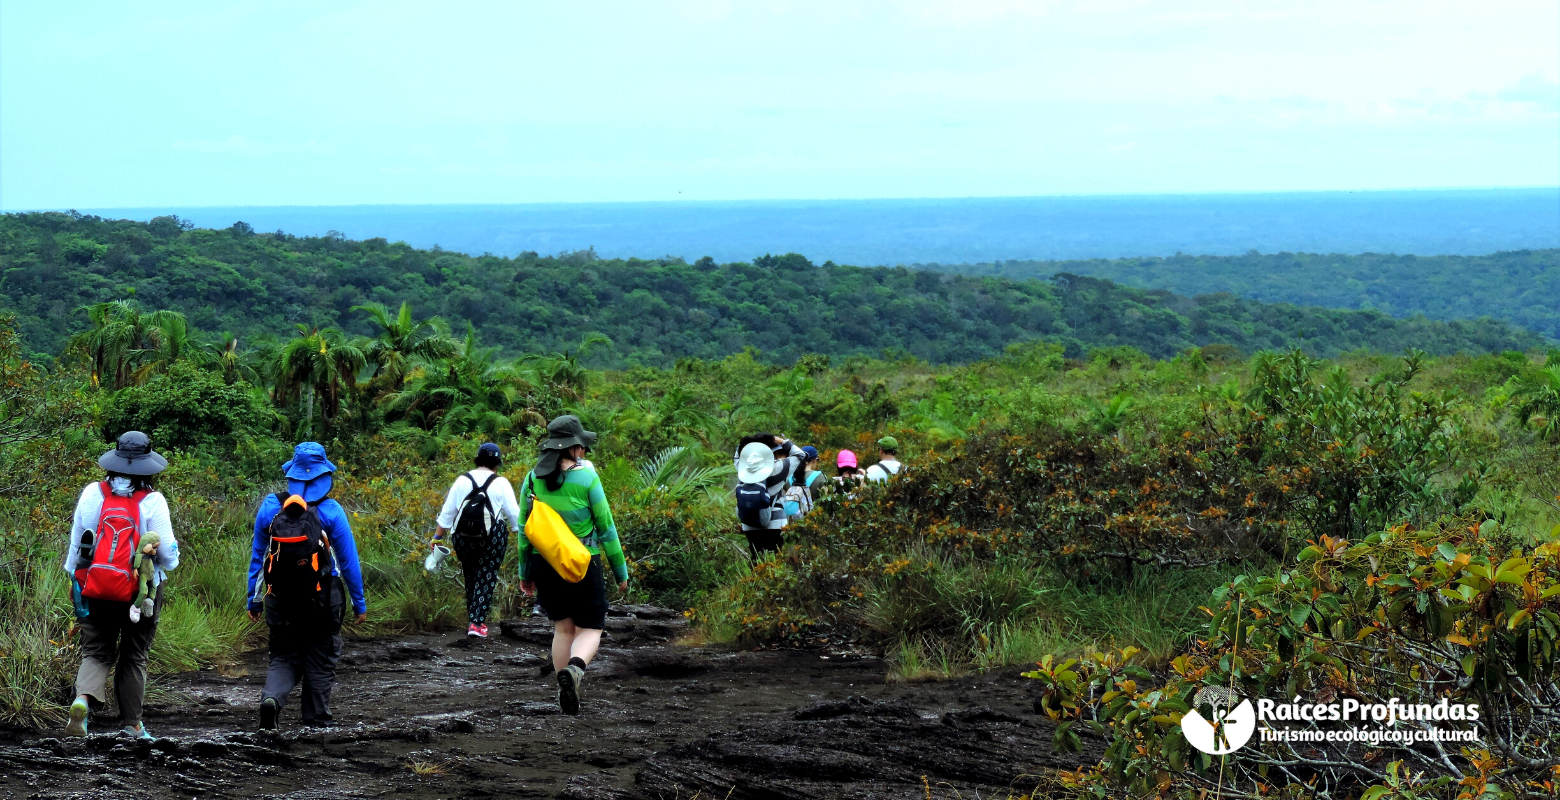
[66,430,179,739]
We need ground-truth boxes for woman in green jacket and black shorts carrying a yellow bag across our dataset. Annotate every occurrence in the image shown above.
[519,413,629,714]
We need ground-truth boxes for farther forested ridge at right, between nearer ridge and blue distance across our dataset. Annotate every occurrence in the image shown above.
[917,250,1560,338]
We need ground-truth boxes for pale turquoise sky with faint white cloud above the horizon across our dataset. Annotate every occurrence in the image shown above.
[0,0,1560,211]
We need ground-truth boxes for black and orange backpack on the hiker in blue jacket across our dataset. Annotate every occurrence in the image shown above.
[265,493,335,618]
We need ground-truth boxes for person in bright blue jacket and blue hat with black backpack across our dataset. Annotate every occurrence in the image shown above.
[248,441,368,730]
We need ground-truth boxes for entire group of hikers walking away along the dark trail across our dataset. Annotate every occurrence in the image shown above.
[64,415,903,739]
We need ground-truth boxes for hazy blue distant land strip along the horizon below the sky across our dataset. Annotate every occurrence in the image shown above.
[80,187,1560,265]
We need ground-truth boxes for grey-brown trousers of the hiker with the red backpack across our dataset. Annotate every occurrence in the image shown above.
[76,586,162,725]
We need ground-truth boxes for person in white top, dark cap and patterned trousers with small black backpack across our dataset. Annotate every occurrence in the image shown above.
[434,441,519,639]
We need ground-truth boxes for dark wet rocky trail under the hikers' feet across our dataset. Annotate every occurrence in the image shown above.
[0,607,1100,800]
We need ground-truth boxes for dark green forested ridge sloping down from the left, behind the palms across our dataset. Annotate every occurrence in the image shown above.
[0,212,1543,368]
